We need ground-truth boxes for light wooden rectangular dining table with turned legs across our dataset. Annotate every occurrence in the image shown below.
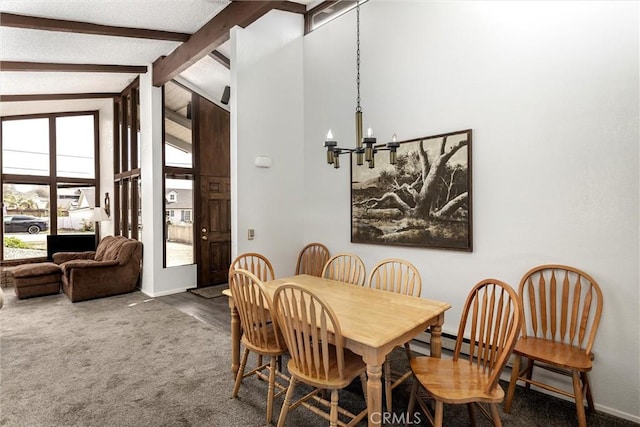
[223,274,451,426]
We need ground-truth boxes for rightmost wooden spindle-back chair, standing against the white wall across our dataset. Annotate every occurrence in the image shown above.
[504,264,603,427]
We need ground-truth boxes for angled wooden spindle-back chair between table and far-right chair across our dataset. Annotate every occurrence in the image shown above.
[407,279,522,427]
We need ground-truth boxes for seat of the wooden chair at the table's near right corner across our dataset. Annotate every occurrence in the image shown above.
[411,357,504,404]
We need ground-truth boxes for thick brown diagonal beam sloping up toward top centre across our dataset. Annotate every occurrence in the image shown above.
[153,1,282,86]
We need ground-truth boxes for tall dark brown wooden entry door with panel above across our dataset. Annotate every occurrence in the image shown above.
[194,95,231,288]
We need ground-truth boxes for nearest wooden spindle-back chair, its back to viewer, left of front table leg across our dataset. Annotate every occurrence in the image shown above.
[273,283,367,427]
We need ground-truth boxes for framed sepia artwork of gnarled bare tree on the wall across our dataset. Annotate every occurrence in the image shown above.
[351,129,473,252]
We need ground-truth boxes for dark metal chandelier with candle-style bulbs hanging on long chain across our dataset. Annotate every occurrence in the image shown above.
[324,0,400,169]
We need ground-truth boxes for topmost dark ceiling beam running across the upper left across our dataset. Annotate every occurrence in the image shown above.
[0,12,191,42]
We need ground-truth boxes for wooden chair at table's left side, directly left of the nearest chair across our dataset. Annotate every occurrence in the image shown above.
[229,269,288,424]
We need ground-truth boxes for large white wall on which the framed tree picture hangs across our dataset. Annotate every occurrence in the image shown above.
[304,0,640,421]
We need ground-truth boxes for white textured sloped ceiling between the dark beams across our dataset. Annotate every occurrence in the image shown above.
[0,0,229,116]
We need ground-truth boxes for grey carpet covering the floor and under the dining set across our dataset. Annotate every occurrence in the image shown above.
[0,289,637,427]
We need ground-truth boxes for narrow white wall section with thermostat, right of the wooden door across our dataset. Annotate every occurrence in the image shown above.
[230,11,304,276]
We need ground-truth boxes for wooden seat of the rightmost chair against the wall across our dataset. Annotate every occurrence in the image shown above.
[513,337,593,372]
